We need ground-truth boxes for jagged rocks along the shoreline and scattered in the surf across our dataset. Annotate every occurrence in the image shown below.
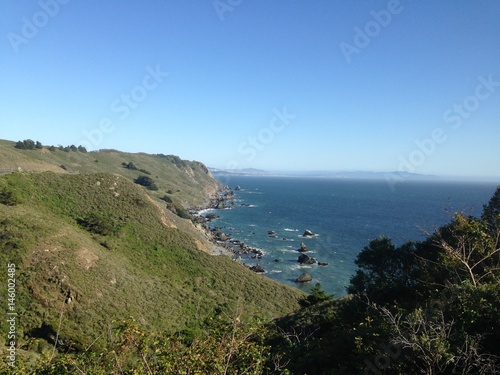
[190,186,328,283]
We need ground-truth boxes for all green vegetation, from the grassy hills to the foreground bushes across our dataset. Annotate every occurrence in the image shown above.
[0,141,500,375]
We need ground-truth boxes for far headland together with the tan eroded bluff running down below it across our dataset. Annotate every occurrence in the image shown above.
[0,140,229,253]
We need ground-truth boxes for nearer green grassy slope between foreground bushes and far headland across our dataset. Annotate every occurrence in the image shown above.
[0,172,301,352]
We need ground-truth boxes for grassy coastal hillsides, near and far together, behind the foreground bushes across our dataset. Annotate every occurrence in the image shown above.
[0,141,302,356]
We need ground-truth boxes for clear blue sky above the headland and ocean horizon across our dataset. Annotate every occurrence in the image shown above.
[0,0,500,177]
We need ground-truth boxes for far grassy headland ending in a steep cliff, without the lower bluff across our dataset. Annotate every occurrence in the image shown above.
[0,140,220,207]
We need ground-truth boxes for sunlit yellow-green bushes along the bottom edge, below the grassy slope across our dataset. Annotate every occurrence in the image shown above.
[0,314,278,375]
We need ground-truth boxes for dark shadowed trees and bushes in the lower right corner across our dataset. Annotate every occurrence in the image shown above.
[266,187,500,374]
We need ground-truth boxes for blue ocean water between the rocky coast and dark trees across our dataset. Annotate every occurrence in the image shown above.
[206,176,496,296]
